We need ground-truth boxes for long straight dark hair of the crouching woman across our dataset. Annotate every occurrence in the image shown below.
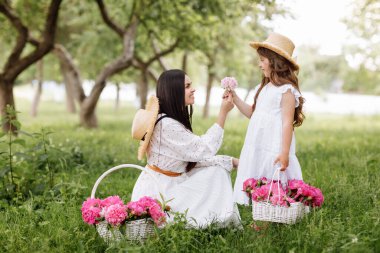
[156,69,196,172]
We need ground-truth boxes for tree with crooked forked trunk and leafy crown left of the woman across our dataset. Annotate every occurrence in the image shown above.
[53,0,233,127]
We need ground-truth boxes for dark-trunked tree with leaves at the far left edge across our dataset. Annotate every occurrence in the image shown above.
[0,0,61,133]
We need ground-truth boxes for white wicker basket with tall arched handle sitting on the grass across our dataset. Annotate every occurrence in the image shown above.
[91,164,162,243]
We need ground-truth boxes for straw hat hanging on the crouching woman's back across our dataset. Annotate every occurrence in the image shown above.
[132,96,160,160]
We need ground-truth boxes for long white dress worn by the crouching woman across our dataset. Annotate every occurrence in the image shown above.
[132,115,240,227]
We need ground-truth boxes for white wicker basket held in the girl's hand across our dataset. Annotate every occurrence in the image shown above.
[252,168,310,224]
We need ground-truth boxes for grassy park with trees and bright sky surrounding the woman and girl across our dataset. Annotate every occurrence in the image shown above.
[0,0,380,252]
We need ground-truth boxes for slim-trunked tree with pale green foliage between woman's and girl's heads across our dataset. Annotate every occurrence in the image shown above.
[199,0,284,118]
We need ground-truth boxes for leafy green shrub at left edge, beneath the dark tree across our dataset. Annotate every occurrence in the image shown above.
[0,106,84,205]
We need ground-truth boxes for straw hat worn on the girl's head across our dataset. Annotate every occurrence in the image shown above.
[249,33,299,70]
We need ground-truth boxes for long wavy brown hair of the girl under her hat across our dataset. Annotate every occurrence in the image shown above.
[252,47,305,127]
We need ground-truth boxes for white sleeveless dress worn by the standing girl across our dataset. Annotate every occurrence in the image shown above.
[234,83,302,205]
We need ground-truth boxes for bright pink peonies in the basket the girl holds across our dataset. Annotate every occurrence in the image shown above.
[243,177,324,207]
